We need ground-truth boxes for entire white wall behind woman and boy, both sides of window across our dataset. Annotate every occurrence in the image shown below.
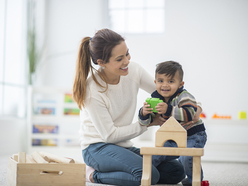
[37,0,248,119]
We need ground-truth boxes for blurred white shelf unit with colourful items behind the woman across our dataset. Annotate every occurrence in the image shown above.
[27,86,81,156]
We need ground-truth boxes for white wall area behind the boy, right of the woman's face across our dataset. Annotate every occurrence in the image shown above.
[127,0,248,119]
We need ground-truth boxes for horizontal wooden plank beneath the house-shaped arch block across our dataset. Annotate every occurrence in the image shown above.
[140,147,204,156]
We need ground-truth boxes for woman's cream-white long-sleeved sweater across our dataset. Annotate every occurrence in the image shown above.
[79,62,156,150]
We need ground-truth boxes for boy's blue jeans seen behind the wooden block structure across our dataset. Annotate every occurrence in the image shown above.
[152,131,207,183]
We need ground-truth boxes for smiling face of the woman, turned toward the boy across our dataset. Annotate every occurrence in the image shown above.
[101,41,131,84]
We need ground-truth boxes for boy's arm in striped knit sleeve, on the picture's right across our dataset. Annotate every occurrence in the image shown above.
[163,91,197,122]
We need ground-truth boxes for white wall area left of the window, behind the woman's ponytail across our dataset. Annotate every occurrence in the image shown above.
[37,0,106,88]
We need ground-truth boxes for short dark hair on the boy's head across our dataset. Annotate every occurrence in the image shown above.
[155,61,183,81]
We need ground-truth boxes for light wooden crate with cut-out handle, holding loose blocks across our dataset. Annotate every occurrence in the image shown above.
[7,157,85,186]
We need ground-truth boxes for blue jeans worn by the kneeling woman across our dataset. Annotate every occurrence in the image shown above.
[83,143,185,186]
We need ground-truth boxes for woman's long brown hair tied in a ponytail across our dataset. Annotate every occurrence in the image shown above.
[73,29,125,109]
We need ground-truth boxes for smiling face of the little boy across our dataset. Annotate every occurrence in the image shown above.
[154,71,184,102]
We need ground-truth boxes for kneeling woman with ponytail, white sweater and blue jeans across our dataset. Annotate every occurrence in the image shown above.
[73,29,200,186]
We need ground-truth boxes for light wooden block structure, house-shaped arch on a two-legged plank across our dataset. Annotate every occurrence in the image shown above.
[140,117,204,186]
